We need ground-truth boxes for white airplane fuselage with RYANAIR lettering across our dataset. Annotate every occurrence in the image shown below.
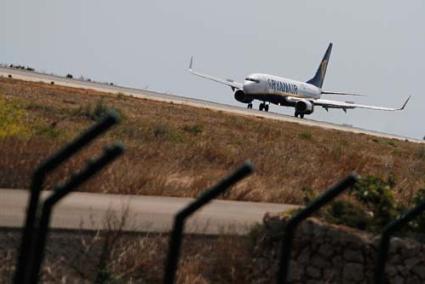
[243,73,322,99]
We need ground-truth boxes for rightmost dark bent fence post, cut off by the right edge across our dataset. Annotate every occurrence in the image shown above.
[375,202,425,283]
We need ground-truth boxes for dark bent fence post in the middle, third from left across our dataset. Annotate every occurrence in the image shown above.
[164,162,253,284]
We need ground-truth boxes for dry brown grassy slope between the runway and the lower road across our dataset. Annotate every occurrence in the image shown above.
[0,78,425,204]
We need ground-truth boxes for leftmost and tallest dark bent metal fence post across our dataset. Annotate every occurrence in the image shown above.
[14,113,119,284]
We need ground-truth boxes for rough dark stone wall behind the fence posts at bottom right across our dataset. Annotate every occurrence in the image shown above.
[250,216,425,283]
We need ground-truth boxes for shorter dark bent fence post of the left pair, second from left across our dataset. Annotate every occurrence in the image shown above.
[27,145,124,283]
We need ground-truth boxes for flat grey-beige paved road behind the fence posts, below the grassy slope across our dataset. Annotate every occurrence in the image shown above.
[0,189,296,235]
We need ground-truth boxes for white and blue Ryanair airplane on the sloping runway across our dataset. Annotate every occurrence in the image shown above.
[189,43,410,118]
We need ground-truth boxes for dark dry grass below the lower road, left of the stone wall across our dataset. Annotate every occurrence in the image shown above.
[0,209,252,283]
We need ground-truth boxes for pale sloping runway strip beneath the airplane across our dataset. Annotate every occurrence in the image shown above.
[0,67,424,143]
